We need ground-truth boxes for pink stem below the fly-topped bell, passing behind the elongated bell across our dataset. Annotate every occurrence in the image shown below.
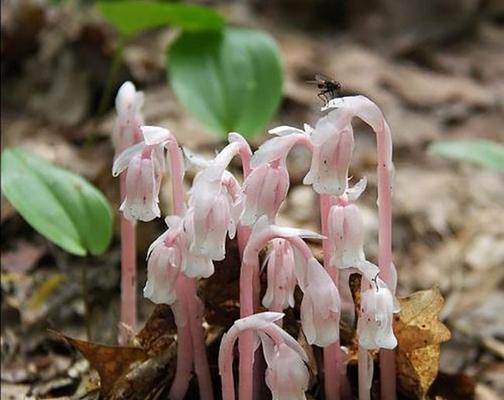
[320,194,342,400]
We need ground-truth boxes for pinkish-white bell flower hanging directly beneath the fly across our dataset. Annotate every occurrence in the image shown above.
[303,110,354,196]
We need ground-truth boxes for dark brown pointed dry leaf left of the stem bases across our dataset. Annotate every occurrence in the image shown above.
[51,331,147,396]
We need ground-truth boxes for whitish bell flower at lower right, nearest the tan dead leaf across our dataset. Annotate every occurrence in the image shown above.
[357,277,397,349]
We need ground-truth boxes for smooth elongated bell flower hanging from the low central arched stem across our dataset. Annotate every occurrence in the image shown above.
[301,257,340,347]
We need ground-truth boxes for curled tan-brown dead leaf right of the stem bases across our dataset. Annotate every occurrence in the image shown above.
[394,287,450,399]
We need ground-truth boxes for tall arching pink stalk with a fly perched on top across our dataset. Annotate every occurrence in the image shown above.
[328,96,396,400]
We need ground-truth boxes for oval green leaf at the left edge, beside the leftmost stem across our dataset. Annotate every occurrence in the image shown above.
[2,149,112,256]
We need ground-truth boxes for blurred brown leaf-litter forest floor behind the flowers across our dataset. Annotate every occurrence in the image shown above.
[1,0,504,399]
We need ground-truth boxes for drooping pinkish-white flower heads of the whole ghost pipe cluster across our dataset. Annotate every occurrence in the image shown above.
[113,82,397,400]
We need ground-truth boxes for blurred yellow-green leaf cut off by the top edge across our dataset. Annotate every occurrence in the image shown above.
[97,0,225,36]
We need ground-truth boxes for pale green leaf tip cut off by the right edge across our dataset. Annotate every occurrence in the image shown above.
[429,139,504,171]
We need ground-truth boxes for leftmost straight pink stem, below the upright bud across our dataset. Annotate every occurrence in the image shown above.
[119,174,137,345]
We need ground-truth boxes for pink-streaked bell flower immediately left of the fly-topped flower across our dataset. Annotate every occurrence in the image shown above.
[241,161,289,225]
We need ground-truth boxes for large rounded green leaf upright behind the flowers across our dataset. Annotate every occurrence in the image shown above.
[168,28,282,137]
